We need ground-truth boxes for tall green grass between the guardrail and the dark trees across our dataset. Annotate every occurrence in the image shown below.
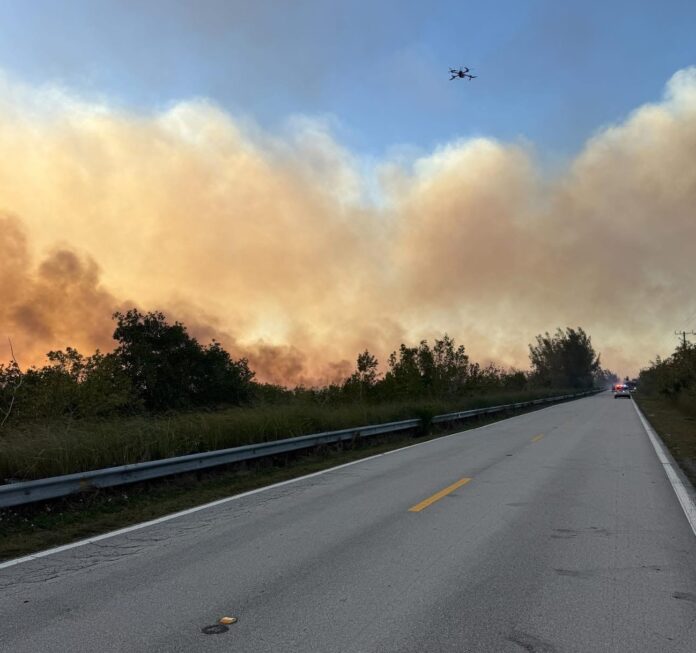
[0,390,564,481]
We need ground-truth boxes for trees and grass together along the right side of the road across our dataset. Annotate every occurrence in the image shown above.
[635,342,696,486]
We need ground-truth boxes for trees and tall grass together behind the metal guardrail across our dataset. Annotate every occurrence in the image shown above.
[0,309,610,482]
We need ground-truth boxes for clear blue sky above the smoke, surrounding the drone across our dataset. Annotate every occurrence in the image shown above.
[0,0,696,158]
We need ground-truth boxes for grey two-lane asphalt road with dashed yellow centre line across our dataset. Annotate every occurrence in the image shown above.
[0,394,696,653]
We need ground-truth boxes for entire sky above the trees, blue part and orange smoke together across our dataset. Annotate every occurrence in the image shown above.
[0,0,696,382]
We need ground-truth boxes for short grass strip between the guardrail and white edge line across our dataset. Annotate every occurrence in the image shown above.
[0,411,524,560]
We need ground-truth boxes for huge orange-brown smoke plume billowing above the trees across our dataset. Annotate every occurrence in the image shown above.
[0,69,696,384]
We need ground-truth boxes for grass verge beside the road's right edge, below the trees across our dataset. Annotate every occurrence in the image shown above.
[634,393,696,487]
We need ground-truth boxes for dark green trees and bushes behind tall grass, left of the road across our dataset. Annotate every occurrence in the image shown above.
[0,309,610,425]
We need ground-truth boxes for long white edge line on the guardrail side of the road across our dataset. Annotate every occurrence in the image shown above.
[0,397,587,569]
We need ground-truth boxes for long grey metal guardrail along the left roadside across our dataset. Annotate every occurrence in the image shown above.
[0,390,596,508]
